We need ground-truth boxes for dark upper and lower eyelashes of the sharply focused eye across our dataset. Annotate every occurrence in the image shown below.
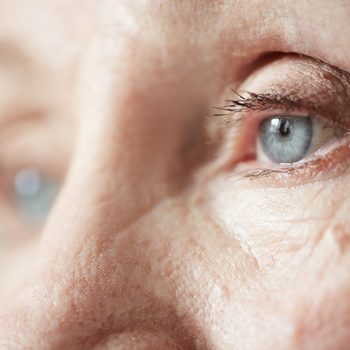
[213,89,350,180]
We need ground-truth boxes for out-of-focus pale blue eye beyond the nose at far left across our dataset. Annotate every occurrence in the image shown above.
[13,169,59,224]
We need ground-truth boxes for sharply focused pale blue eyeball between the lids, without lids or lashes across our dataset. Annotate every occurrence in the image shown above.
[257,116,340,164]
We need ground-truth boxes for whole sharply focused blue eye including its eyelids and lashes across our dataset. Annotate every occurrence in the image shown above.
[216,56,350,185]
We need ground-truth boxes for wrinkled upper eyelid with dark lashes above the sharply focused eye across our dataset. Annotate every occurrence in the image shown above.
[213,54,350,129]
